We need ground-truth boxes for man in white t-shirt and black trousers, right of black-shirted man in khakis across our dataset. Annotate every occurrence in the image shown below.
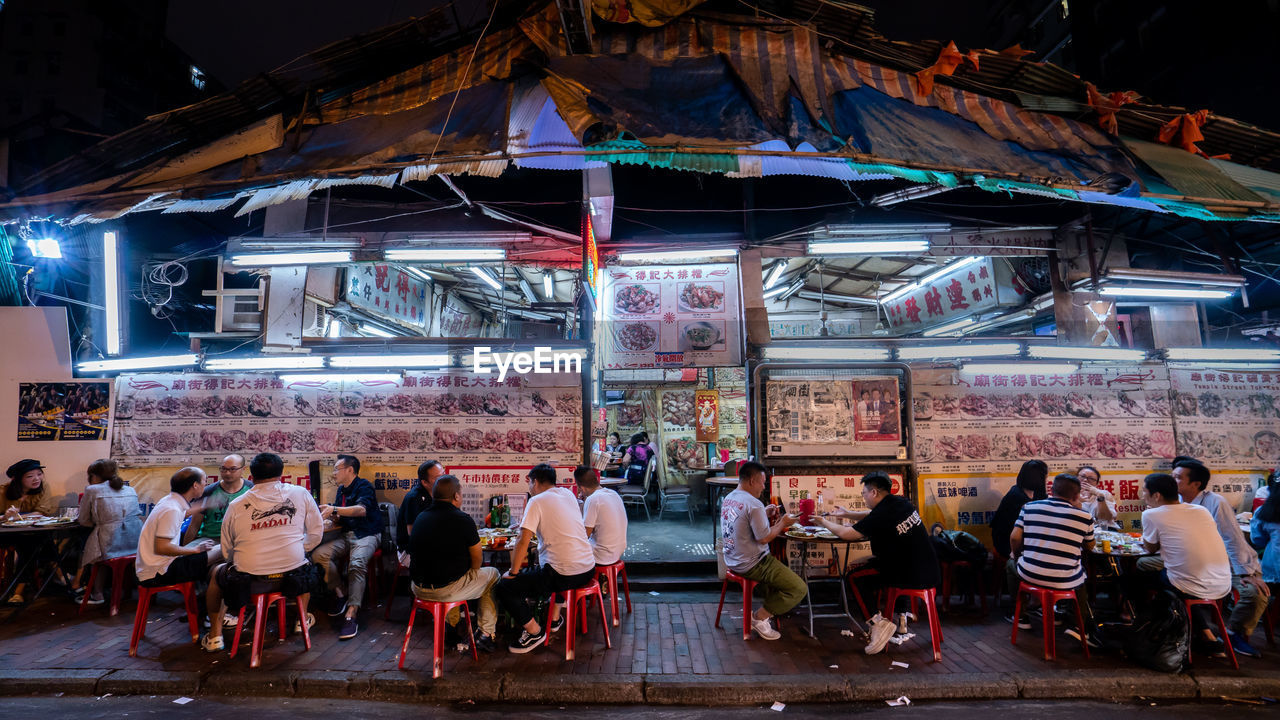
[494,462,595,655]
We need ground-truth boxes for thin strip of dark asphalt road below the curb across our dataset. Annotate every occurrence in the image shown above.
[0,696,1276,720]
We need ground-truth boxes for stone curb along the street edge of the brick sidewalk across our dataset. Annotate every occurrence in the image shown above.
[0,669,1280,707]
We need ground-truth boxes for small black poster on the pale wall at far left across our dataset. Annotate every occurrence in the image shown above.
[17,380,111,442]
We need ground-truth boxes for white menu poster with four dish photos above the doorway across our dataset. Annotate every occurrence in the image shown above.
[602,263,742,369]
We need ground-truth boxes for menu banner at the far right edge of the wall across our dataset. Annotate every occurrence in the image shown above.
[1169,365,1280,511]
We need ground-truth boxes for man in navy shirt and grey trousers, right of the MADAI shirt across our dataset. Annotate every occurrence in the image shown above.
[311,455,383,641]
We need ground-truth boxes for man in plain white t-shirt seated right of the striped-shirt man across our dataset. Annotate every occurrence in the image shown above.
[1125,473,1231,655]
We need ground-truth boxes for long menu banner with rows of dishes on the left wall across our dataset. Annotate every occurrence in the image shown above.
[111,372,582,468]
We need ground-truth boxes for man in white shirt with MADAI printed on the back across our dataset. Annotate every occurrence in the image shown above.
[200,452,324,652]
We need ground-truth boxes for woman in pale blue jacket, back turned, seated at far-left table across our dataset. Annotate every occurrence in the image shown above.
[72,459,142,605]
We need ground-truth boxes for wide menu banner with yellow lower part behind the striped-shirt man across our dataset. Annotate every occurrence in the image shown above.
[913,364,1176,539]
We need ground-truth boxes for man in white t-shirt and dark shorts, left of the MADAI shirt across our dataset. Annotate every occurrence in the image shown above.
[134,468,223,618]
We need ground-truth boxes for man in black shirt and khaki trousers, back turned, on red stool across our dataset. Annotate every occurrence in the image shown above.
[408,475,499,652]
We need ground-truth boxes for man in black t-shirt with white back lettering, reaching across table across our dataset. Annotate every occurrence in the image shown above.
[818,471,940,655]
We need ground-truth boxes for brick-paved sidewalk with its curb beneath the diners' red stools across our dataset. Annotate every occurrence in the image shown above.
[0,594,1280,705]
